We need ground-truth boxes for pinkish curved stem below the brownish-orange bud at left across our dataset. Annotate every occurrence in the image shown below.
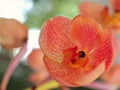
[0,43,27,90]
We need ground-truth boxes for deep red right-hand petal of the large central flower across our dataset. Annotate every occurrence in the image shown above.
[90,32,114,70]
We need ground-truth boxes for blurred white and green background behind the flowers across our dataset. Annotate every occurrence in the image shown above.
[0,0,118,90]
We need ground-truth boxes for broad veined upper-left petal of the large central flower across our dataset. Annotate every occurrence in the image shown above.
[39,16,74,63]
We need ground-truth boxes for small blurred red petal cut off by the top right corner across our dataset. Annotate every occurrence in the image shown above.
[109,0,120,12]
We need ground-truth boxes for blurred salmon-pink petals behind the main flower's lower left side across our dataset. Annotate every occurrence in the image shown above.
[28,48,49,85]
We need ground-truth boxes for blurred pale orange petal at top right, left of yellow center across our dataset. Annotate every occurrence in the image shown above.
[79,2,107,23]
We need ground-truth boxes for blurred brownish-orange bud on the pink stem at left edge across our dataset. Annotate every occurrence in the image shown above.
[0,18,28,49]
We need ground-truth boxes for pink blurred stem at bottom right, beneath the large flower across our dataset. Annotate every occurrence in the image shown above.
[85,81,117,90]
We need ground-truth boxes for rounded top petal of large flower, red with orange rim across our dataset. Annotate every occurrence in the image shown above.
[70,15,103,53]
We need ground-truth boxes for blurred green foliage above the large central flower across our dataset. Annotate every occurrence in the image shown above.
[26,0,80,28]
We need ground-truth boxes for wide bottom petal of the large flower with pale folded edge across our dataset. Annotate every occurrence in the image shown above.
[44,56,105,87]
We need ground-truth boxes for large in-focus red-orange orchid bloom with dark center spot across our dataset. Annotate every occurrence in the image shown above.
[39,15,113,86]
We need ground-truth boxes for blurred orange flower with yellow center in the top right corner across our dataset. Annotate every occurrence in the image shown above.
[79,0,120,33]
